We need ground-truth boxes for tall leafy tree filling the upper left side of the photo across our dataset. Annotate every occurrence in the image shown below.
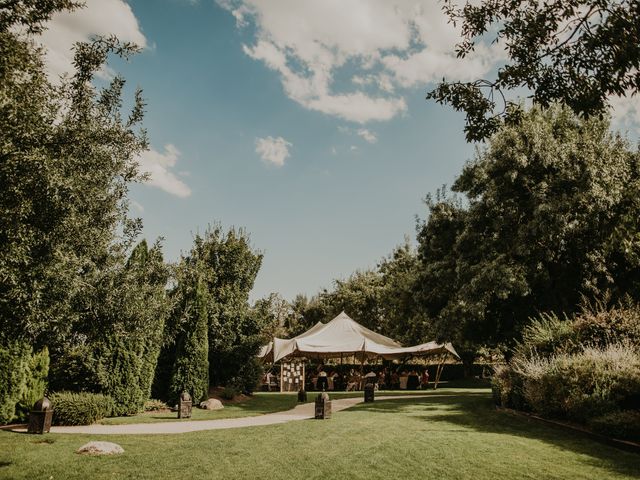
[0,13,147,346]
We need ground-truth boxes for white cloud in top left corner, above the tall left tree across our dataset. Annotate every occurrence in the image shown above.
[40,0,147,77]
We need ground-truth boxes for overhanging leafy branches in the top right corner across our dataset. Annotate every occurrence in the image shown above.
[427,0,640,141]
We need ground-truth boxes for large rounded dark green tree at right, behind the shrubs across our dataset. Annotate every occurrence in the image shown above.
[418,107,640,346]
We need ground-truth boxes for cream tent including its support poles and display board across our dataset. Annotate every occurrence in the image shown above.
[258,312,460,392]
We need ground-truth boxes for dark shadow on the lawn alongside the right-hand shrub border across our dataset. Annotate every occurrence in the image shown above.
[353,392,640,476]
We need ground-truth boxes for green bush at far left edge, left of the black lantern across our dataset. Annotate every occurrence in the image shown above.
[0,341,31,424]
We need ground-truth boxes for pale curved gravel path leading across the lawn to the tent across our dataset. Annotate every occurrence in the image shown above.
[16,395,428,435]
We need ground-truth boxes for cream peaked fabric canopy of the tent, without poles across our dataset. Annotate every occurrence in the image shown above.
[258,312,460,363]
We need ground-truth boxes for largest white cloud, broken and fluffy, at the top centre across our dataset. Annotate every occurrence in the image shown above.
[218,0,501,124]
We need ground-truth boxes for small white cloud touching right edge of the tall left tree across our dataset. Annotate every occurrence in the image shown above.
[138,144,191,198]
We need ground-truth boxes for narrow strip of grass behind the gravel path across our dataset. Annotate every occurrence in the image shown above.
[100,390,440,425]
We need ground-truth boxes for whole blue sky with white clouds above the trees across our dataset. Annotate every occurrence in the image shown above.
[42,0,640,299]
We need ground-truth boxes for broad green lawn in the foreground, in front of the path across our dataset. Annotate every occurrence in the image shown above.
[0,388,640,480]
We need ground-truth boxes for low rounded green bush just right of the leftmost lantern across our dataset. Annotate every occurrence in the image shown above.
[50,392,115,425]
